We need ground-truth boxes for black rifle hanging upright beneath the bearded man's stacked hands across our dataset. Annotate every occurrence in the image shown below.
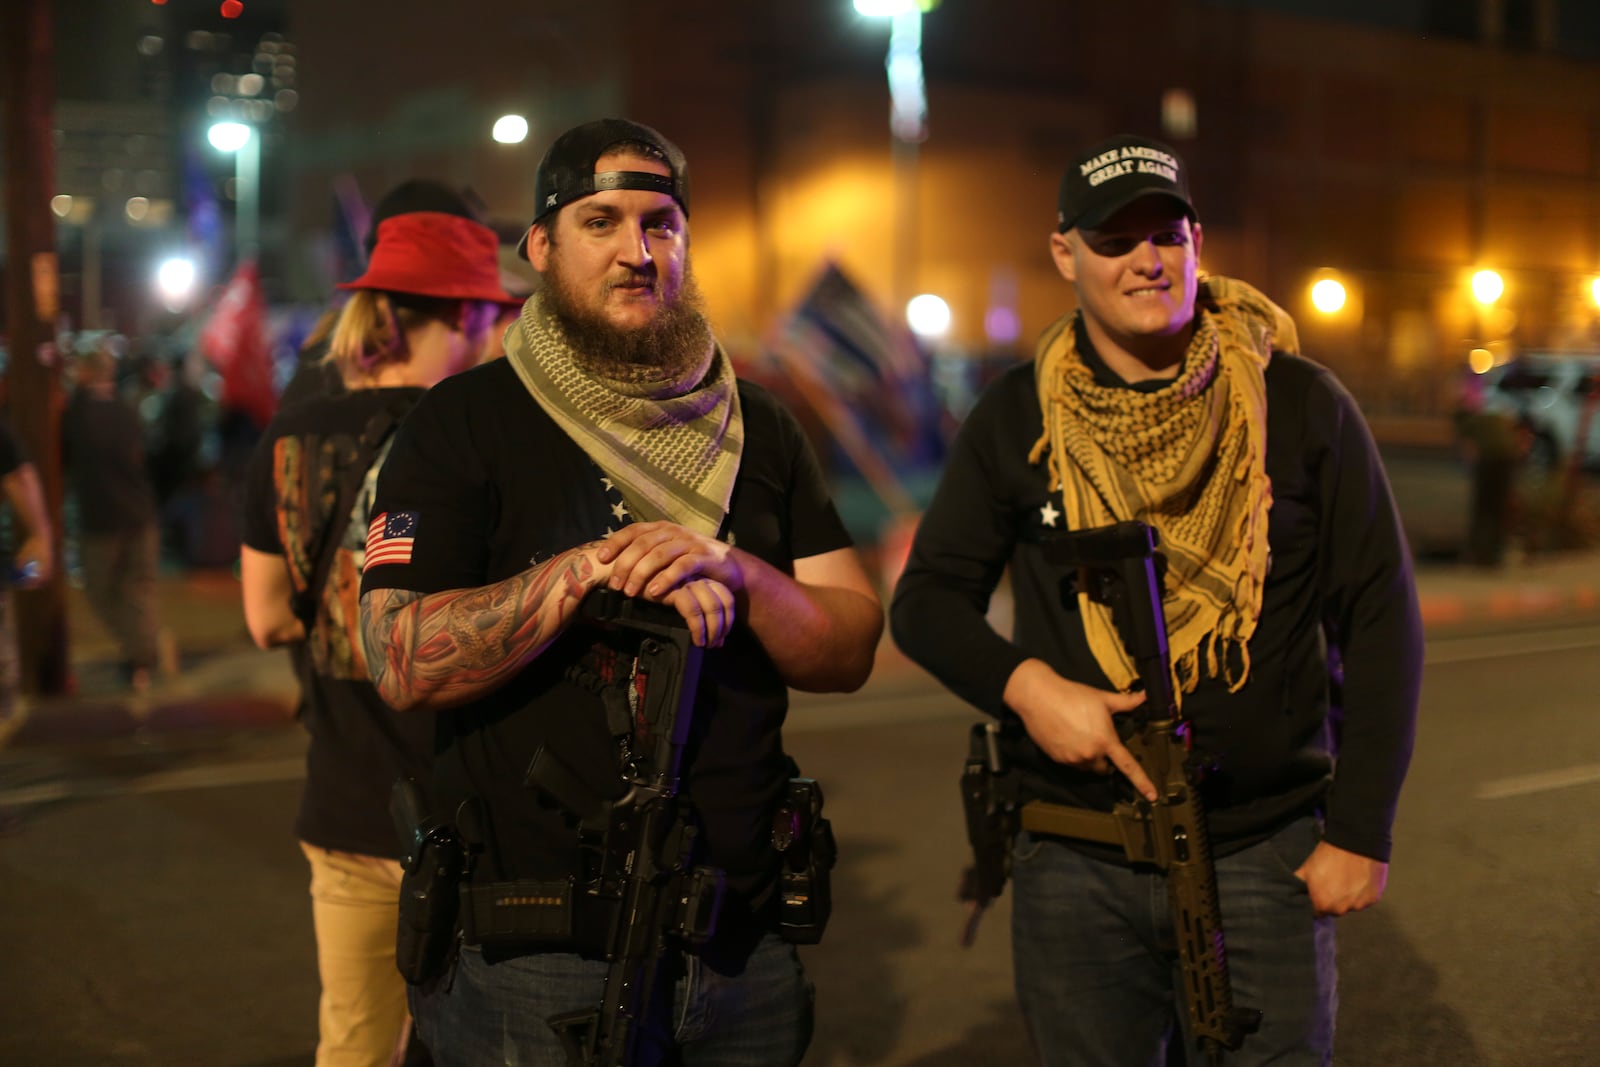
[540,590,723,1067]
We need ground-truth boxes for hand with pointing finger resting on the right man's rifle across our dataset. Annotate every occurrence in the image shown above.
[1005,659,1157,800]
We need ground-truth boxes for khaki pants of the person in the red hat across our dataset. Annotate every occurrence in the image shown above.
[301,841,411,1067]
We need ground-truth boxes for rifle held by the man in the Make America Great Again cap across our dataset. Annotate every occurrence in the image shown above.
[1021,522,1261,1064]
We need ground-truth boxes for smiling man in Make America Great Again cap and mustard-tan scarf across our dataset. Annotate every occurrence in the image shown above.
[890,136,1422,1067]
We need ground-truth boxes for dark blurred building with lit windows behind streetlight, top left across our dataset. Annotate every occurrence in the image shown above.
[0,0,294,333]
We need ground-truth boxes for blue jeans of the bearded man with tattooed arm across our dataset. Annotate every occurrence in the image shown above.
[411,934,814,1067]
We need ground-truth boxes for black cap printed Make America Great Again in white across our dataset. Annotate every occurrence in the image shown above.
[1056,134,1200,234]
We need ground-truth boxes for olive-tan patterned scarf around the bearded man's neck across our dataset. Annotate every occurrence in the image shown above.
[506,294,744,537]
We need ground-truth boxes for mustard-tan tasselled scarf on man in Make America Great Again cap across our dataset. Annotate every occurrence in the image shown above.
[1029,277,1299,701]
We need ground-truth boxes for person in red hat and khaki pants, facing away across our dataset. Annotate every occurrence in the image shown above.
[240,211,514,1067]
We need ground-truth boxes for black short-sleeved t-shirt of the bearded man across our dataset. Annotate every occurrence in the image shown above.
[362,360,850,899]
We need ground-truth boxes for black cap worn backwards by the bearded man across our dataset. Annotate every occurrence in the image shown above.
[517,118,690,259]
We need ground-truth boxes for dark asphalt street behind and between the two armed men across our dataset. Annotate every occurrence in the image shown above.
[0,617,1600,1067]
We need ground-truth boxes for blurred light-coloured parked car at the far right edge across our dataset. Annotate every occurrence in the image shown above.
[1482,352,1600,469]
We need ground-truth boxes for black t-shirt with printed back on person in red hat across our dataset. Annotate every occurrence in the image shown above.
[243,389,434,857]
